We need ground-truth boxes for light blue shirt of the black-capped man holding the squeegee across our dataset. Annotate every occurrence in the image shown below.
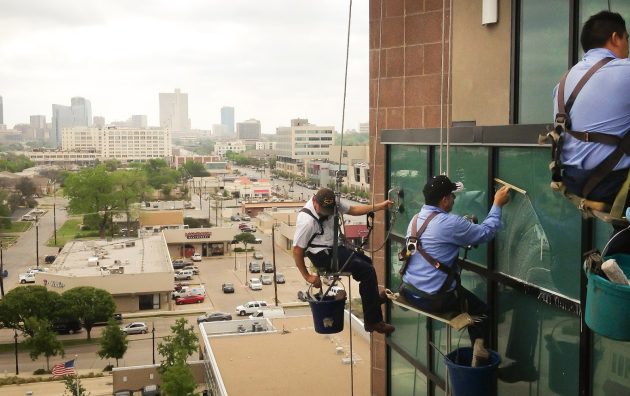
[403,205,501,294]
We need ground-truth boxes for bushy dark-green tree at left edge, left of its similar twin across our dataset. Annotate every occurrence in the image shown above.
[0,285,62,335]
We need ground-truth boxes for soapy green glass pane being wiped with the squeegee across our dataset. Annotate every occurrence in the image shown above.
[496,148,582,298]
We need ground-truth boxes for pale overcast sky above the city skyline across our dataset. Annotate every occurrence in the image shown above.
[0,0,368,133]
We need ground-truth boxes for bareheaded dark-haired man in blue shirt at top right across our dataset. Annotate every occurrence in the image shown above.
[554,11,630,203]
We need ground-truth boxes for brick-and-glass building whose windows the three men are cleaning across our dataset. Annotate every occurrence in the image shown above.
[369,0,630,396]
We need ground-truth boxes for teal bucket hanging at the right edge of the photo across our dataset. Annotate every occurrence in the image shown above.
[584,254,630,341]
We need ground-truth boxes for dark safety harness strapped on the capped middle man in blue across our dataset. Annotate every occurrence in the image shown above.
[398,212,461,298]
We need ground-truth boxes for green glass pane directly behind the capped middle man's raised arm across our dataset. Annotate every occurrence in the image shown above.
[433,146,489,267]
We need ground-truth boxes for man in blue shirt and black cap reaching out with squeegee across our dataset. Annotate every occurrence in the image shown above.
[401,175,510,343]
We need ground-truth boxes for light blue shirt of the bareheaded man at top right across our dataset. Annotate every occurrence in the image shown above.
[553,48,630,170]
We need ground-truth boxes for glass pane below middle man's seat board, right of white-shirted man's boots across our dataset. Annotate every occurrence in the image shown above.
[390,298,427,366]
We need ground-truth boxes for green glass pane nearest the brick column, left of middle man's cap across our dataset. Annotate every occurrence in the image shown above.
[389,146,428,237]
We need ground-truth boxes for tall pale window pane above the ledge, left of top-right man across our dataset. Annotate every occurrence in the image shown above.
[518,0,571,124]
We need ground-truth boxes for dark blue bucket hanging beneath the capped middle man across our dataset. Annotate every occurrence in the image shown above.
[444,347,501,396]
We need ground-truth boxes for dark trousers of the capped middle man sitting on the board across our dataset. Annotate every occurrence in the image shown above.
[400,287,489,345]
